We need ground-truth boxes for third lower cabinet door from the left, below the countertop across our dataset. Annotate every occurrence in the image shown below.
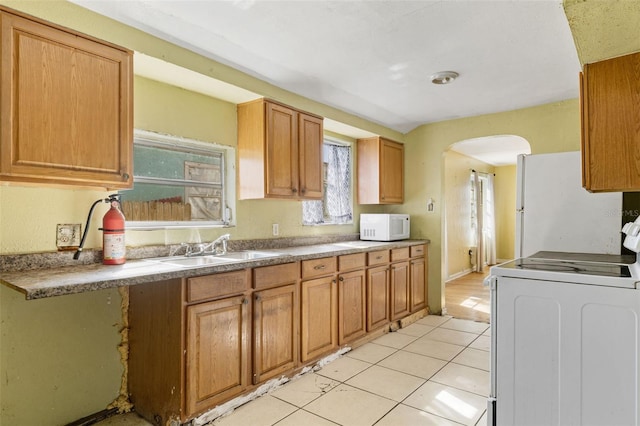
[301,275,338,361]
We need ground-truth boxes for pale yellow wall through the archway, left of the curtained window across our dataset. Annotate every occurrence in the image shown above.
[443,150,495,279]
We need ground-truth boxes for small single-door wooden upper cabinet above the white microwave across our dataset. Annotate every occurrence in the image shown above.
[357,137,404,204]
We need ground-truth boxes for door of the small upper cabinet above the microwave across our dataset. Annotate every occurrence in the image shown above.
[380,139,404,204]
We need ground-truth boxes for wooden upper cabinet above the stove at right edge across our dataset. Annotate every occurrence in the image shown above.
[580,53,640,192]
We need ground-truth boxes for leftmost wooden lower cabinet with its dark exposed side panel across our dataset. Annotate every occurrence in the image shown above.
[128,270,252,425]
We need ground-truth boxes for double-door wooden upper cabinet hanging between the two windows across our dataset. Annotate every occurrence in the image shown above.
[238,99,323,199]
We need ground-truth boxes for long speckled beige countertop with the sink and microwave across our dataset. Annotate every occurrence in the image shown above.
[0,240,429,300]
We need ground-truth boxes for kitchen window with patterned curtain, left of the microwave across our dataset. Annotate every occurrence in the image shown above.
[302,139,353,225]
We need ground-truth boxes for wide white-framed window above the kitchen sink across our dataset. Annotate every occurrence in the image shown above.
[120,130,234,228]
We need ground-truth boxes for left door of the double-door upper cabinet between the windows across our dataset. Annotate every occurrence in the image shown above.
[265,102,298,197]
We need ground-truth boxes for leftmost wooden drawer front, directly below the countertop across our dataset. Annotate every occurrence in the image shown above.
[187,269,249,303]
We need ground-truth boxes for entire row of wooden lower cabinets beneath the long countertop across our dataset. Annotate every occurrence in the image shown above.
[128,245,427,425]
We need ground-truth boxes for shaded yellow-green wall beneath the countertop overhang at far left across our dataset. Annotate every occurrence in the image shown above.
[0,286,123,426]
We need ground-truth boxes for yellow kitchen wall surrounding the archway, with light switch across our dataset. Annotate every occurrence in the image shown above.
[403,99,580,313]
